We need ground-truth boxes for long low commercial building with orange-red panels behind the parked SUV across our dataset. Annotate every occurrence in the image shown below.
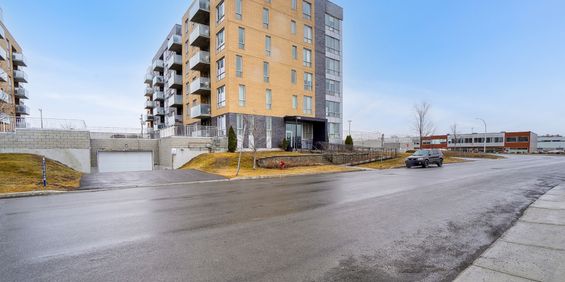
[421,131,538,153]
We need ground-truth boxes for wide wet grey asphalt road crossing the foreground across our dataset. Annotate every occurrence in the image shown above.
[0,156,565,281]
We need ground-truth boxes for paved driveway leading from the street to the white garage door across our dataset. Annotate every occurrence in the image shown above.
[79,170,226,190]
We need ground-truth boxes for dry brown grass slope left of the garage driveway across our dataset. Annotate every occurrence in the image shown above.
[0,154,82,194]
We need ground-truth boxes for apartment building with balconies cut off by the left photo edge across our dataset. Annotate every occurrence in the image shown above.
[0,10,29,124]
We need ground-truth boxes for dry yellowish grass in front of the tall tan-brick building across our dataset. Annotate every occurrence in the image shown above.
[181,151,356,178]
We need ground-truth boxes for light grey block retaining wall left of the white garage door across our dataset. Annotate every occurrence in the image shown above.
[0,129,90,173]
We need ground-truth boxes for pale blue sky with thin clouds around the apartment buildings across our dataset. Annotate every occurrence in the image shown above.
[0,0,565,135]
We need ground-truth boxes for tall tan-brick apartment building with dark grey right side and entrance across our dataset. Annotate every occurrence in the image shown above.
[182,0,343,148]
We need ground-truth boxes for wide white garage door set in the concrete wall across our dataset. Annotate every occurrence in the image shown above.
[98,152,153,172]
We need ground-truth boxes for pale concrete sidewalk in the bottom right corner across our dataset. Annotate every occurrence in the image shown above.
[455,184,565,282]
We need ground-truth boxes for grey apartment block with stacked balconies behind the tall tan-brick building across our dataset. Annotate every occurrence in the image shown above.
[144,24,184,131]
